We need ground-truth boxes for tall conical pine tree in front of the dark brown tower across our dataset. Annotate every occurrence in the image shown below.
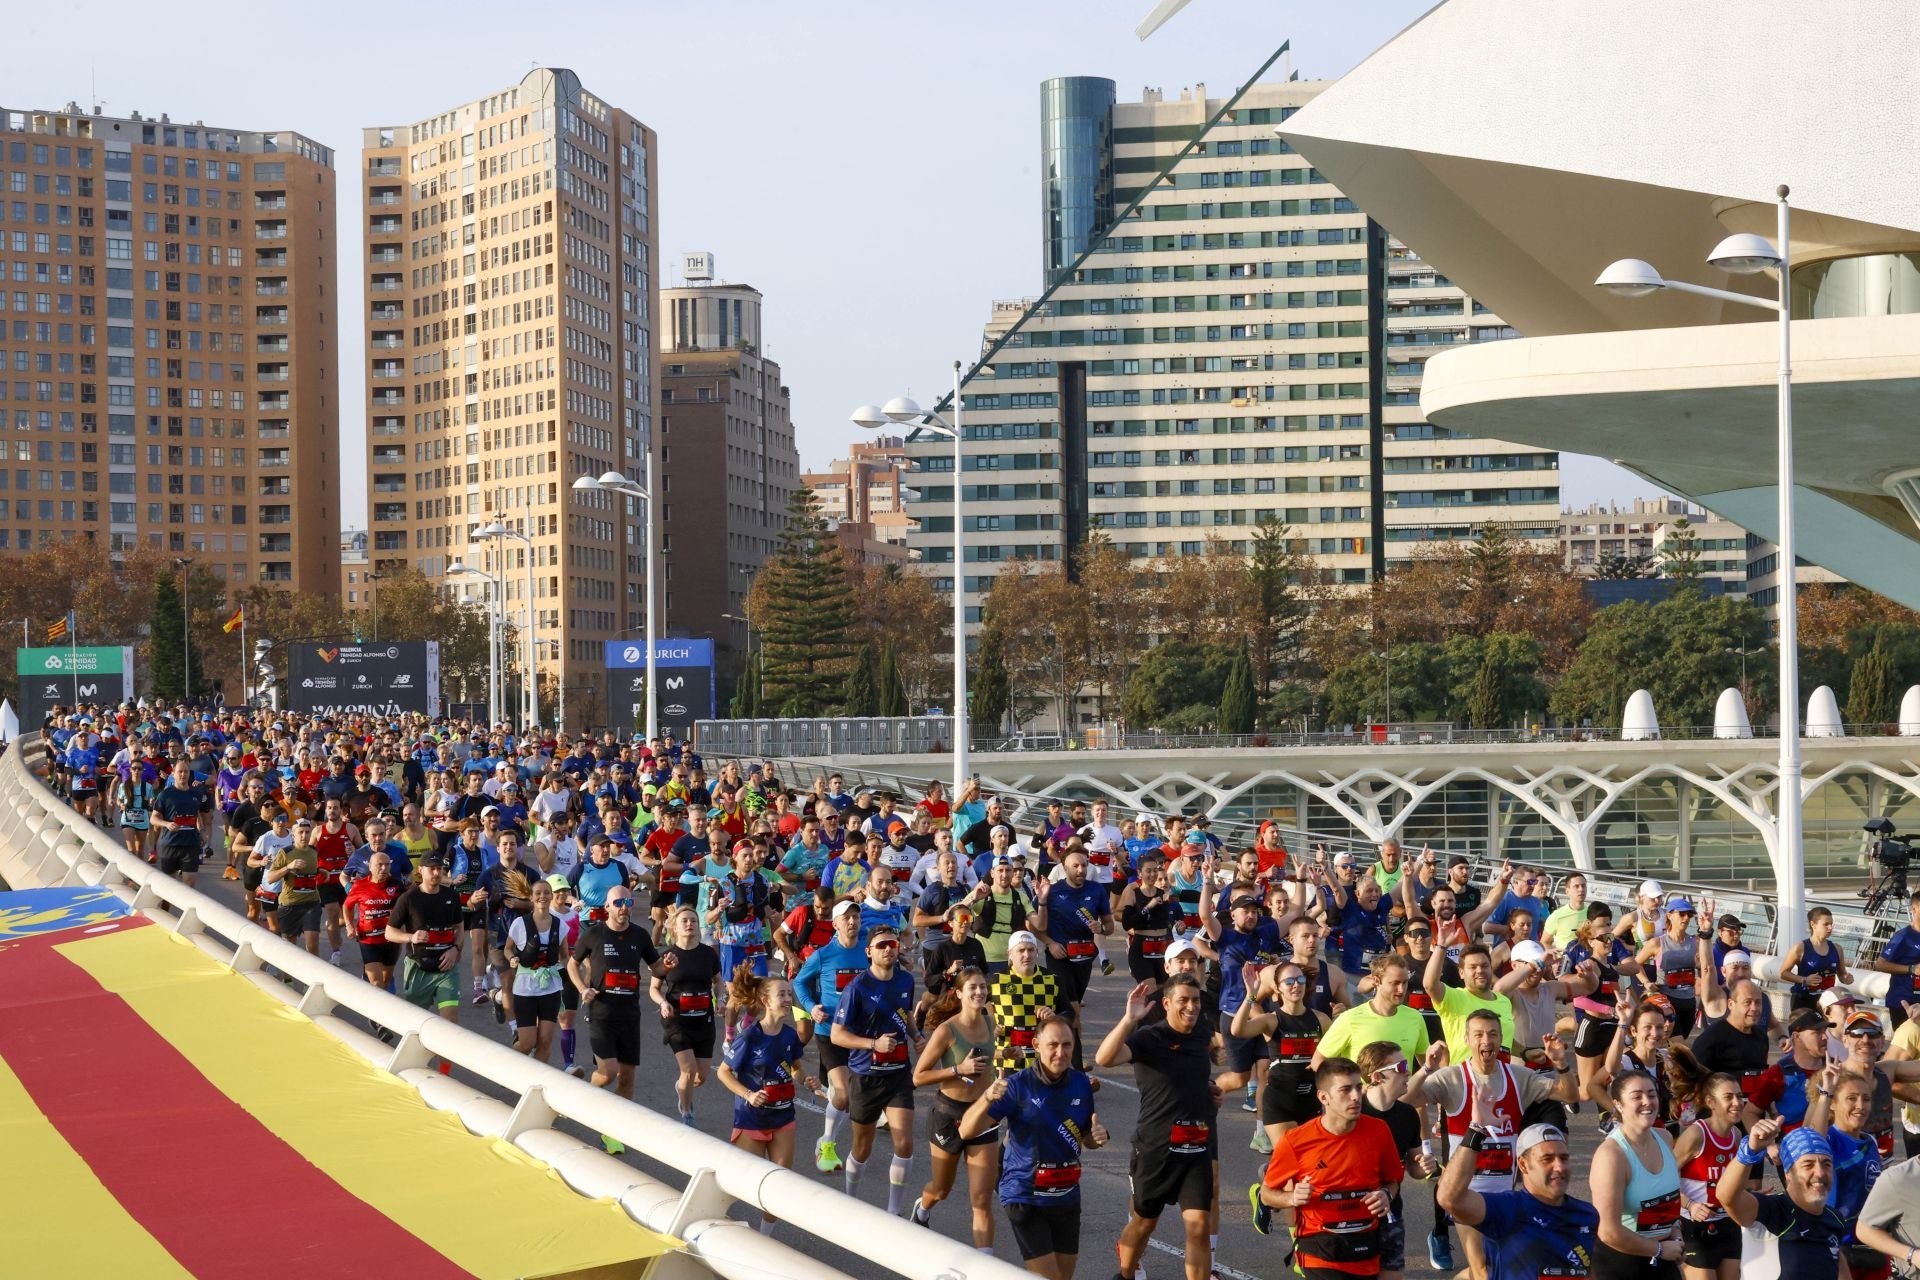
[760,486,854,716]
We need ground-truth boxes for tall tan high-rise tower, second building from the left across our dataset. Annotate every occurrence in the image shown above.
[365,67,659,729]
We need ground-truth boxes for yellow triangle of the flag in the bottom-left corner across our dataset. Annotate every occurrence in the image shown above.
[0,1061,190,1280]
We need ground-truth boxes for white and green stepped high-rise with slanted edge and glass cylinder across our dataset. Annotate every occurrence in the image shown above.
[908,77,1559,660]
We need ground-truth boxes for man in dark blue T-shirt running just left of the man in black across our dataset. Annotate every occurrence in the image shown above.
[960,1017,1108,1276]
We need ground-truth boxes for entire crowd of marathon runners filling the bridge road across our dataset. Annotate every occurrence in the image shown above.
[30,706,1920,1280]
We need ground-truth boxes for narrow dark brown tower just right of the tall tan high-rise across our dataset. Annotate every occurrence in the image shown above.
[659,253,801,670]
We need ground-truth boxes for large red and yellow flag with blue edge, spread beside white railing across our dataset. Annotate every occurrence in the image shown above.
[0,889,680,1280]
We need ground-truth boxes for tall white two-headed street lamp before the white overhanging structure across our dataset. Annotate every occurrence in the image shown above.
[1594,184,1807,952]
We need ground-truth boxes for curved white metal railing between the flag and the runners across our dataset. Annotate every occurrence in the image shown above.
[0,735,1025,1280]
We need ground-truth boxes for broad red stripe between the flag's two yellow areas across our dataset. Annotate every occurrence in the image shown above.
[0,933,468,1280]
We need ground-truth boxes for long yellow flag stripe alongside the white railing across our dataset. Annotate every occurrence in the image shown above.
[61,929,676,1280]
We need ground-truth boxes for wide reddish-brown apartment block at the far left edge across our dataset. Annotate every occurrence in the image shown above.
[0,102,340,595]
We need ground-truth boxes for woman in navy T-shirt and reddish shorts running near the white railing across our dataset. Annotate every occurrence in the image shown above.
[718,974,820,1236]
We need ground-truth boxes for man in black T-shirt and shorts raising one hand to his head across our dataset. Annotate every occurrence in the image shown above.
[1094,973,1221,1280]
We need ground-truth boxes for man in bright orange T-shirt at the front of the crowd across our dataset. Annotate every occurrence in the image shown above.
[1256,1057,1405,1280]
